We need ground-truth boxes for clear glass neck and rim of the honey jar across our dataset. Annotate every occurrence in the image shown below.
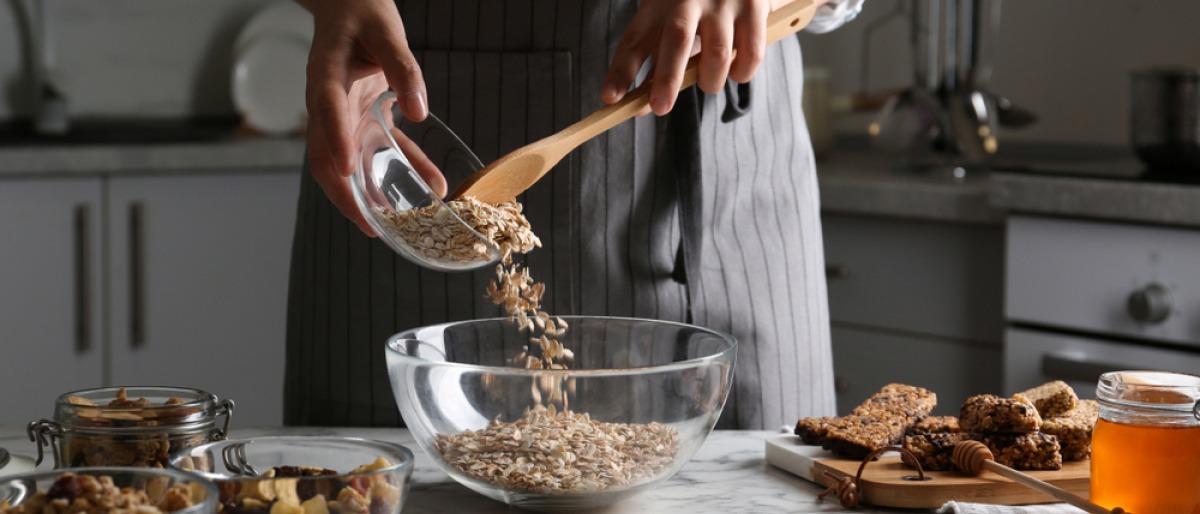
[1096,370,1200,418]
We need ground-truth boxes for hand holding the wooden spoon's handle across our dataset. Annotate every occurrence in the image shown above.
[600,0,782,115]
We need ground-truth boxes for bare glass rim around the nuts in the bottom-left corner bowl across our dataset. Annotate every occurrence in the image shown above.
[0,467,218,514]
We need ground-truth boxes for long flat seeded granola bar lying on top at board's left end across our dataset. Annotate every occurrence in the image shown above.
[821,384,937,459]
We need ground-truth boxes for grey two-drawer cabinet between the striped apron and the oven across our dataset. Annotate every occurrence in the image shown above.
[822,213,1004,414]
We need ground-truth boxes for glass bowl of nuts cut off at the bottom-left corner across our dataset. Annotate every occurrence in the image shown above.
[0,467,217,514]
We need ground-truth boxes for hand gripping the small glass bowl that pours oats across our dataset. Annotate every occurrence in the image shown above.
[296,0,446,235]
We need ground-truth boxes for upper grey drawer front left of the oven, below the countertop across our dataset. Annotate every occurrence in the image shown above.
[822,214,1004,347]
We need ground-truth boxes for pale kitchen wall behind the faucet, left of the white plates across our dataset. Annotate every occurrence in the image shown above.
[0,0,271,119]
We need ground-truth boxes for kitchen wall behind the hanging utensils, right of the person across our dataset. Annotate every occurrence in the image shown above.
[802,0,1200,144]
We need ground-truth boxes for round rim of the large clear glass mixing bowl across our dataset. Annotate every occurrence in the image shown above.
[384,315,738,377]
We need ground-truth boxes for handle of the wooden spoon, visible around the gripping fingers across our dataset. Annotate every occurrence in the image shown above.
[559,0,817,146]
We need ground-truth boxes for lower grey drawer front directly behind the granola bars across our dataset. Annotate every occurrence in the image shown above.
[833,323,1002,416]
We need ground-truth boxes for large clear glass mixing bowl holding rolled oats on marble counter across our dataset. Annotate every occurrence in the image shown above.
[386,316,737,510]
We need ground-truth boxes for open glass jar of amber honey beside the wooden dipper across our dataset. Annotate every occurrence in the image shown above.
[1091,371,1200,514]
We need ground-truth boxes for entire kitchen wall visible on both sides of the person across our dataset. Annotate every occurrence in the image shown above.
[0,0,1200,144]
